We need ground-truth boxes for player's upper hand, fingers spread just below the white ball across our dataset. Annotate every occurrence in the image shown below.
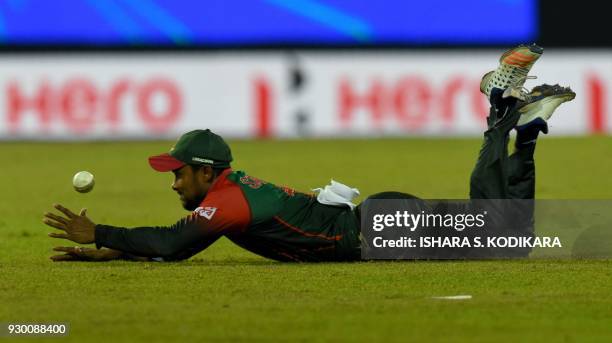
[43,204,96,244]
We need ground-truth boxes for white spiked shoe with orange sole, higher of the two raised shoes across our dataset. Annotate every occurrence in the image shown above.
[480,44,544,101]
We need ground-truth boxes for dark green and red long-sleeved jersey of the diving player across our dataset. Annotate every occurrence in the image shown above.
[96,169,361,261]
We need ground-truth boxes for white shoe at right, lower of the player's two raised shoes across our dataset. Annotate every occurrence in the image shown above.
[516,84,576,133]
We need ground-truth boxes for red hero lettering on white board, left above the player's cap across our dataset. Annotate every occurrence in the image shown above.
[5,77,183,134]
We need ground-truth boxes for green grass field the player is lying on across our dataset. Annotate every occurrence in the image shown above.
[0,137,612,343]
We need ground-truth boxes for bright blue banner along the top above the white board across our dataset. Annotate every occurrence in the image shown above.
[0,0,537,46]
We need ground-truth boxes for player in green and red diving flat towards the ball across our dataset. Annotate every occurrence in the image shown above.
[43,45,575,262]
